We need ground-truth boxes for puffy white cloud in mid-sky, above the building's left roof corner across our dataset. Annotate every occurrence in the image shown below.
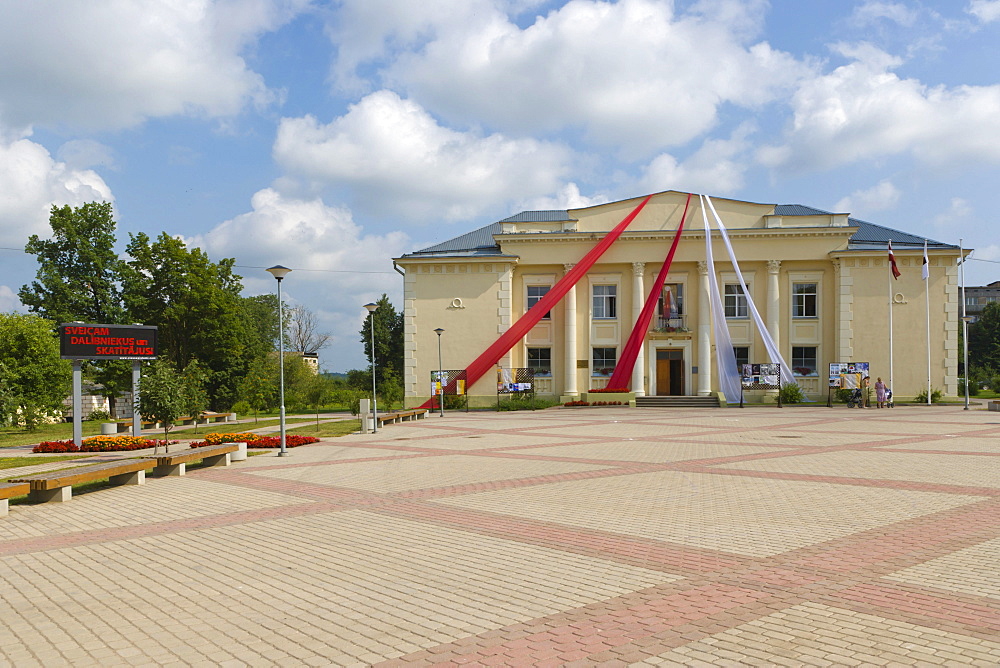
[274,91,571,221]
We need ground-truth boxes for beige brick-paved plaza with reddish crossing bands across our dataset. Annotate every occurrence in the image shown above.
[0,406,1000,668]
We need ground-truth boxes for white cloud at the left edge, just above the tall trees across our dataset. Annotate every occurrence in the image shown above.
[0,139,114,248]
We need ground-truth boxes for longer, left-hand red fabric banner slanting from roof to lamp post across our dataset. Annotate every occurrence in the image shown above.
[420,195,653,408]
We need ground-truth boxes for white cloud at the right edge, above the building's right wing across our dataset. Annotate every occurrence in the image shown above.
[758,45,1000,170]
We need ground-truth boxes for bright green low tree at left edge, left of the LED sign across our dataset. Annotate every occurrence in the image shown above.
[0,313,73,430]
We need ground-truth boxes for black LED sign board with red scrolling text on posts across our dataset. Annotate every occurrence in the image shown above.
[59,322,156,360]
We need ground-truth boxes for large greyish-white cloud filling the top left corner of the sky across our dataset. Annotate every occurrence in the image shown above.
[0,0,308,129]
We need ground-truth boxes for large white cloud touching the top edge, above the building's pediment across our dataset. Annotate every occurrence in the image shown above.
[332,0,811,156]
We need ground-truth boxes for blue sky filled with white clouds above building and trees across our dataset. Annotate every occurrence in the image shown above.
[0,0,1000,371]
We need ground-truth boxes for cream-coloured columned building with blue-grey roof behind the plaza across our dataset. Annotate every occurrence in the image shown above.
[396,191,959,406]
